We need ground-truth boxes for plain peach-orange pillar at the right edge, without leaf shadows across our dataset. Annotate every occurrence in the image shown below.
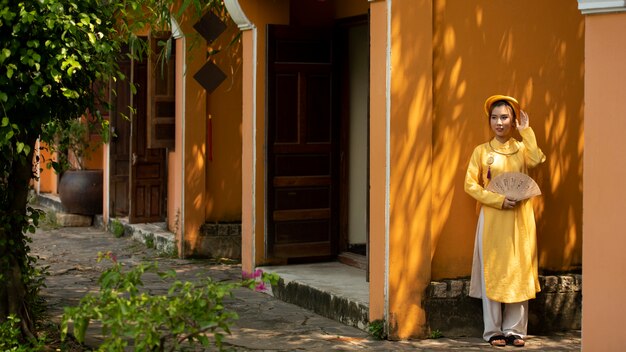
[582,9,626,351]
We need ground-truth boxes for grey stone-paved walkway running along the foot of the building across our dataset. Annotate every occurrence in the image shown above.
[31,227,581,351]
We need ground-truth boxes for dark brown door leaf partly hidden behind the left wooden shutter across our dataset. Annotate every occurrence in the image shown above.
[129,57,166,223]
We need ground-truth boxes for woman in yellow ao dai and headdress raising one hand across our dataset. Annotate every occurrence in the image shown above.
[465,95,545,346]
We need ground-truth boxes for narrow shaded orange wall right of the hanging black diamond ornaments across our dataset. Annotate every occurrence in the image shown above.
[206,17,242,221]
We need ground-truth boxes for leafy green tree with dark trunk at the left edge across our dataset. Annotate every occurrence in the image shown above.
[0,0,223,340]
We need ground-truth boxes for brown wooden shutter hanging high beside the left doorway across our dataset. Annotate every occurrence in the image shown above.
[147,32,176,148]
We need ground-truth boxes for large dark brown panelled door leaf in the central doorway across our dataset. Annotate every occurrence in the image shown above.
[267,25,339,258]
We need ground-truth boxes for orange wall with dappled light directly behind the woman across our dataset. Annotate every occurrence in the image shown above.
[432,0,584,279]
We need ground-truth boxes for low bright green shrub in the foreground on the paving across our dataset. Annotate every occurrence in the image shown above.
[61,252,278,351]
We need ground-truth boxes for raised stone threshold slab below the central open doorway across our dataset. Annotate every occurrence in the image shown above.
[260,262,369,330]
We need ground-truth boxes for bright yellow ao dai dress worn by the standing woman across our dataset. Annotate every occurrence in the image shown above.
[465,127,546,303]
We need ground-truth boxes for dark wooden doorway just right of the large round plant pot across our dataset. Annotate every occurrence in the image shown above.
[109,43,167,223]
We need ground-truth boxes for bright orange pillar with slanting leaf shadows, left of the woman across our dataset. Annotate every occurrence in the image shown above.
[388,0,433,339]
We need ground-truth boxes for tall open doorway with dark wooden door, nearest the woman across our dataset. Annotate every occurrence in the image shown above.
[266,16,369,268]
